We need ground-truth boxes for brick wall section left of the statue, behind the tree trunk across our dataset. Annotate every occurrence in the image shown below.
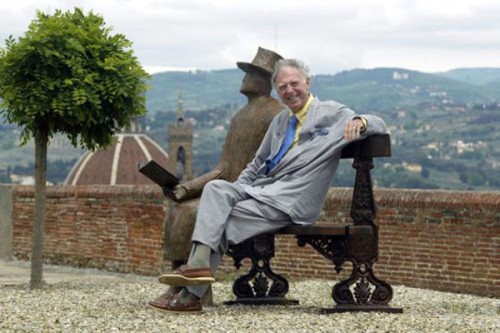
[12,185,170,274]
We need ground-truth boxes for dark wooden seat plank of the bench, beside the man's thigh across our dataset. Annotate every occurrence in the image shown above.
[276,224,373,236]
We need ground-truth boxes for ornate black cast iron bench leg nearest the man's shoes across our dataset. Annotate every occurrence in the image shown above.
[225,234,299,305]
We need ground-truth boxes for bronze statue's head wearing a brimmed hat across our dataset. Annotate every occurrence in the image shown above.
[236,47,283,95]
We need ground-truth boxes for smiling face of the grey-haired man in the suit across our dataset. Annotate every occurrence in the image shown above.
[275,66,309,113]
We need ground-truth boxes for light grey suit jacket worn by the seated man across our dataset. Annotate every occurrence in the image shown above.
[236,98,388,224]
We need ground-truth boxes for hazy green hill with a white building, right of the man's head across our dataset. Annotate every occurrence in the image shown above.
[311,68,500,112]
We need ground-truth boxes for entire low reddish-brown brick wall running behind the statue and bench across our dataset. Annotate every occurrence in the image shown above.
[8,186,500,297]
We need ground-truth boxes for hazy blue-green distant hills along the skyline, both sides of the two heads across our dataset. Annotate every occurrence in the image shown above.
[147,68,500,114]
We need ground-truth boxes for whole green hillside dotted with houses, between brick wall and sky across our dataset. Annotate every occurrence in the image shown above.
[0,68,500,190]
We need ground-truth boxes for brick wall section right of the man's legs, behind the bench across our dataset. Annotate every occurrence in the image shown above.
[239,188,500,296]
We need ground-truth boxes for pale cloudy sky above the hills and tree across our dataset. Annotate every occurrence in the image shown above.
[0,0,500,74]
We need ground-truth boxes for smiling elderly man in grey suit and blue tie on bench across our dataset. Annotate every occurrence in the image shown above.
[153,59,387,312]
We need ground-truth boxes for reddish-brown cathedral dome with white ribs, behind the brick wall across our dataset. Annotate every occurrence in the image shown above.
[64,119,172,185]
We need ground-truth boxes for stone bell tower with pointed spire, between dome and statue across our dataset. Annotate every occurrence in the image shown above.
[168,92,193,181]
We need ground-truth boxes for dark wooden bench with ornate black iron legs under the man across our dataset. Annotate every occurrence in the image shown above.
[226,134,402,313]
